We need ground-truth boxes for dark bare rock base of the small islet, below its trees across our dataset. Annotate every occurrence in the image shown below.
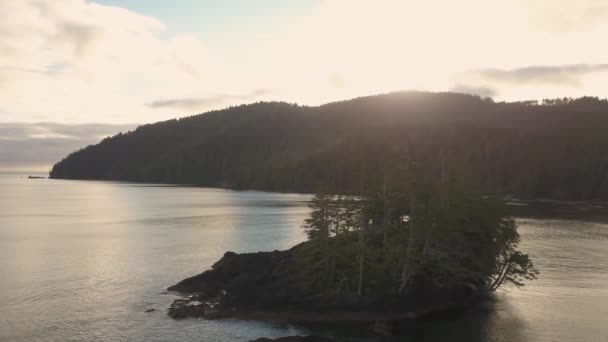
[167,244,479,324]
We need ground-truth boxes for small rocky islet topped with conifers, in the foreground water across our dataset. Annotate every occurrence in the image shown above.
[167,156,538,331]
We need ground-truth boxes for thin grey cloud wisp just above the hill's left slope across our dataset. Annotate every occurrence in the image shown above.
[146,88,272,110]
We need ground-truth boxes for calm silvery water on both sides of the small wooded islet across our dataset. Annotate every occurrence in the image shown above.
[0,174,608,342]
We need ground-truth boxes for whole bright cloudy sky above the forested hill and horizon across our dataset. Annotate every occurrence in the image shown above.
[0,0,608,170]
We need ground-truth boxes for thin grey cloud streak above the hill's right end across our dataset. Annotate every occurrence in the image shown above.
[472,64,608,86]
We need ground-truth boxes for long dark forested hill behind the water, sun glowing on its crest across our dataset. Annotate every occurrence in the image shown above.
[50,92,608,200]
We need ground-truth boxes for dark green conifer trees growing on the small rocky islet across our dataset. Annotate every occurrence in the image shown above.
[302,158,538,299]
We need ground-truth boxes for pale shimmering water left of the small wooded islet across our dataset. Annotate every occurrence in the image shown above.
[0,175,314,341]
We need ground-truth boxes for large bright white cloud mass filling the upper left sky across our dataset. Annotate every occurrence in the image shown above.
[0,0,243,123]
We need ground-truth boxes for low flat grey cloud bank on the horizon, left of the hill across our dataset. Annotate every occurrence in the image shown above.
[0,123,135,171]
